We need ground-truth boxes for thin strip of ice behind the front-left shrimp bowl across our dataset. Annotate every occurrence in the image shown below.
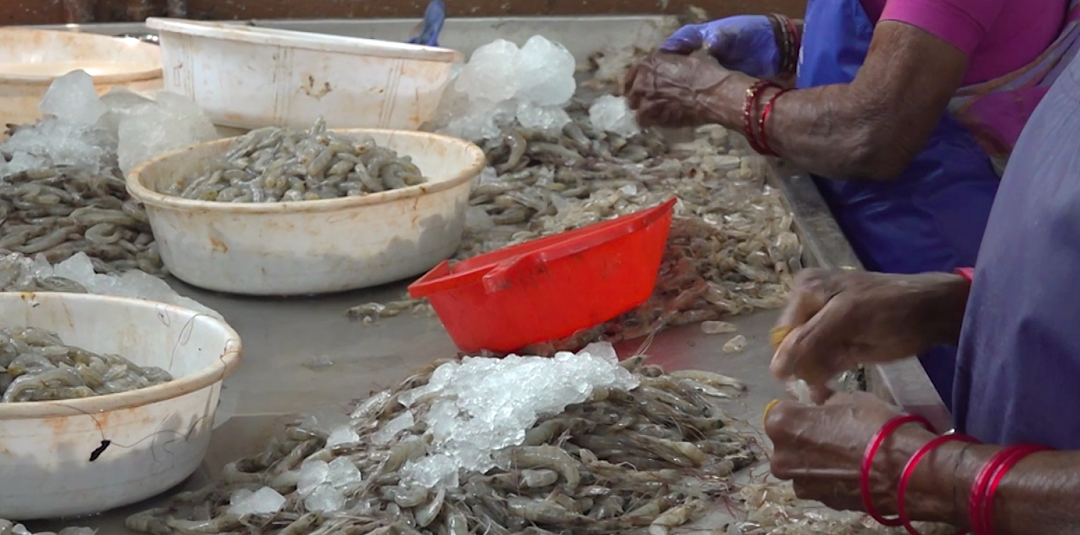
[0,253,224,319]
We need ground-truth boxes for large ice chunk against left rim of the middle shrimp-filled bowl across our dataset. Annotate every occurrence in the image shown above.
[117,91,217,174]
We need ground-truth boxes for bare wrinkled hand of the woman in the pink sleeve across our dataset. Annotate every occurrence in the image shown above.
[625,52,731,128]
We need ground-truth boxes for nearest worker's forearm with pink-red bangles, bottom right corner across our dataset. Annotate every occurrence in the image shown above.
[908,443,1080,535]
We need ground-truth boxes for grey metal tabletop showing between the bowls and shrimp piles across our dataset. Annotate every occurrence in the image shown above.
[14,16,949,535]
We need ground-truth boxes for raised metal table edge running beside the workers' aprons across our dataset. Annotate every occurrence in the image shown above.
[770,162,953,430]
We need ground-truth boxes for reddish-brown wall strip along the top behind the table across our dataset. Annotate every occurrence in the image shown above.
[6,0,806,25]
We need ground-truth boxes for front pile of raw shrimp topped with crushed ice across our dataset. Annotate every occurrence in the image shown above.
[120,353,756,535]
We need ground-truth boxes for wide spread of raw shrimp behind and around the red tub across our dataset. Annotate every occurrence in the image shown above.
[348,48,801,355]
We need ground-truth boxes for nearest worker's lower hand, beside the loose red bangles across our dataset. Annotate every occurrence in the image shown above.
[765,392,933,514]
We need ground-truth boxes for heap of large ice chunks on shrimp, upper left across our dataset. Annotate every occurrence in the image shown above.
[0,70,218,177]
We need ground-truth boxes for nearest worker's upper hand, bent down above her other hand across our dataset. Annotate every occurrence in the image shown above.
[771,269,968,403]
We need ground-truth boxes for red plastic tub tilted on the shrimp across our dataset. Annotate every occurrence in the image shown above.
[408,199,676,353]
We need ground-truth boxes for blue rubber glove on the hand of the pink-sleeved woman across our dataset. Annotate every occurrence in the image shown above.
[660,15,780,78]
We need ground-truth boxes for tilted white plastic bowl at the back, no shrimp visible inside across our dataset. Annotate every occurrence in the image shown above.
[146,17,463,130]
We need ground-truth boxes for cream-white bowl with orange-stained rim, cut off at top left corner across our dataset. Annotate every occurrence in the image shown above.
[0,28,162,124]
